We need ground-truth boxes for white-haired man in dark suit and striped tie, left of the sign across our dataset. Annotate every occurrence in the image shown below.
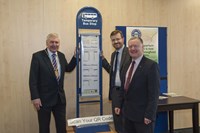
[29,33,76,133]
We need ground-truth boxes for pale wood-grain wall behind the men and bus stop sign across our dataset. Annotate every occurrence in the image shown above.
[0,0,200,133]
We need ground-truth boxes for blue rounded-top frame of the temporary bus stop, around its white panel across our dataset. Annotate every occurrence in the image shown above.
[76,7,103,117]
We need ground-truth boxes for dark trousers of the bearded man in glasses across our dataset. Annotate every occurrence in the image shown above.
[112,87,124,133]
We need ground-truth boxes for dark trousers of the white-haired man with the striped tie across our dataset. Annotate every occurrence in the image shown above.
[38,97,67,133]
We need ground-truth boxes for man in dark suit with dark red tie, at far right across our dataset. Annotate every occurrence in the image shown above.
[115,37,160,133]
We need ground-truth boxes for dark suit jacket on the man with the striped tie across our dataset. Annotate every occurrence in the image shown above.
[29,50,76,106]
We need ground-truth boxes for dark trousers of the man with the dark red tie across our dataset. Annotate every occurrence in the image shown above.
[124,118,155,133]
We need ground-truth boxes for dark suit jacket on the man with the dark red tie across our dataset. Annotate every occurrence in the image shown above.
[117,56,160,122]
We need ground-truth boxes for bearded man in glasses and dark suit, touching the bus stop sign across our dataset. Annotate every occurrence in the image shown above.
[102,30,130,133]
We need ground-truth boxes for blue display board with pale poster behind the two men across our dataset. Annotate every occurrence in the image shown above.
[116,26,168,133]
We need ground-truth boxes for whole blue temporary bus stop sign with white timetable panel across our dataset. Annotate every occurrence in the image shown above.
[76,7,103,117]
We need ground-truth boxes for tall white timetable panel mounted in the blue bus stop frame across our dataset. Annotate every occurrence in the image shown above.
[81,34,100,96]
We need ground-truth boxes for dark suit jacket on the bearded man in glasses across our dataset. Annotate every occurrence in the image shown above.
[102,46,130,100]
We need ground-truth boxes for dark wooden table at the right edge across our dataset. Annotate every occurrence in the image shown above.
[157,96,200,133]
